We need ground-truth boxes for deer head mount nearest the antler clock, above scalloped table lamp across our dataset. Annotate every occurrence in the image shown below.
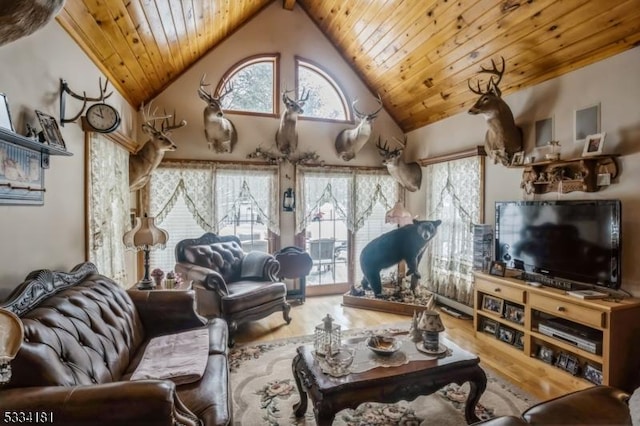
[129,103,187,191]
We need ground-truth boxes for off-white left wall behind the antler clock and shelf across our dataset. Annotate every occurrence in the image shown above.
[0,22,135,292]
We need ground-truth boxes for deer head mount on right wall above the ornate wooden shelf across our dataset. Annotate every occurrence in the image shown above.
[467,58,522,166]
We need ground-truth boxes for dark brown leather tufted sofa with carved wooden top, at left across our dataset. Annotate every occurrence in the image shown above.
[0,263,232,426]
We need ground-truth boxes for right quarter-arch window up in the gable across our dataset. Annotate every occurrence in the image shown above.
[296,57,351,121]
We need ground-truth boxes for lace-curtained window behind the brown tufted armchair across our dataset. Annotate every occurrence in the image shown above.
[149,162,280,272]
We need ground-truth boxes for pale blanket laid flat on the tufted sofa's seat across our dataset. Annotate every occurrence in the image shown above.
[131,328,209,385]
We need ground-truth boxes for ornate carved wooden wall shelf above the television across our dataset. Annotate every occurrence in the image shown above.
[520,155,618,194]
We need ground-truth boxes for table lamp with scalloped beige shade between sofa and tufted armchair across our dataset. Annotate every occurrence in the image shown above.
[122,214,169,290]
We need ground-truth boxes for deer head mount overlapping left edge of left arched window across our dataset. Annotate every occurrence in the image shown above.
[198,74,238,153]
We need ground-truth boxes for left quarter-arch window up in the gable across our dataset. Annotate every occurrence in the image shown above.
[216,54,280,115]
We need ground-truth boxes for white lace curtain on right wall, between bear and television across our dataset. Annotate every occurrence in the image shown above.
[419,156,482,306]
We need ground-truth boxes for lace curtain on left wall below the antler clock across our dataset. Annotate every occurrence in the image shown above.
[88,133,131,286]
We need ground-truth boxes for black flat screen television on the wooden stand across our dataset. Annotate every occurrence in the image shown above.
[495,200,622,289]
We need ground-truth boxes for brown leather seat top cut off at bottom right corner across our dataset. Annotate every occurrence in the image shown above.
[475,386,631,426]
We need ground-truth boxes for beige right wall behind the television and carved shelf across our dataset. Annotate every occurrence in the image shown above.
[407,47,640,296]
